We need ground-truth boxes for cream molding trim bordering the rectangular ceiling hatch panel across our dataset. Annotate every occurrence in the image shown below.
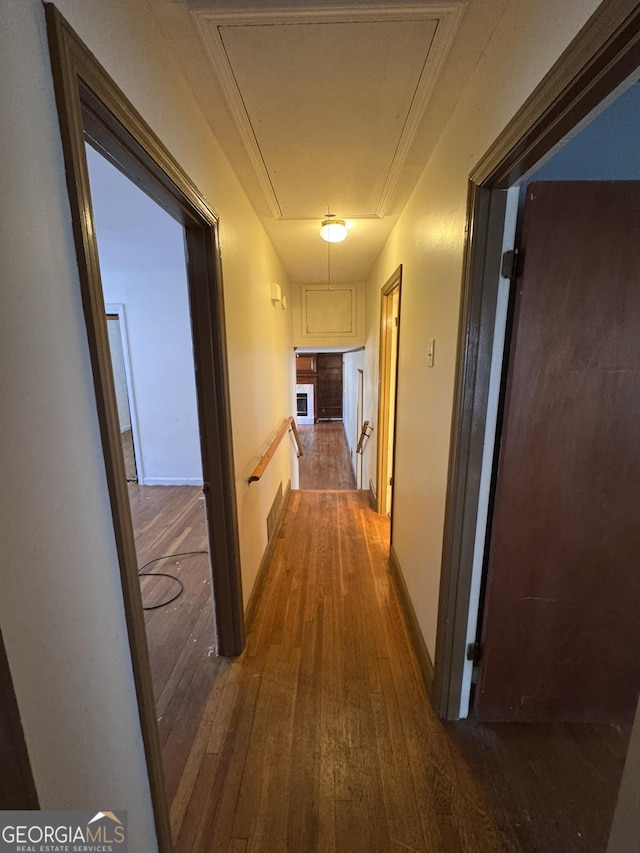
[188,0,467,220]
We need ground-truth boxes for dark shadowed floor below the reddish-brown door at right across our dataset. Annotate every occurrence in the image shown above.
[445,720,628,853]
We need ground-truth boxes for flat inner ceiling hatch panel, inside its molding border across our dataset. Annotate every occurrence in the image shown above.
[219,20,436,219]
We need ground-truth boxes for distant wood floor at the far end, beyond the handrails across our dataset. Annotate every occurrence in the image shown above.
[298,421,356,489]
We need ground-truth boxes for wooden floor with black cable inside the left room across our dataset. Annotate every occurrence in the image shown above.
[129,483,224,802]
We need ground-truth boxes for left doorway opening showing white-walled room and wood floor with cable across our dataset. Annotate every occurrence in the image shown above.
[86,141,220,801]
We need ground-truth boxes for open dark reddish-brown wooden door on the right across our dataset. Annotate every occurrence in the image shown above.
[475,181,640,721]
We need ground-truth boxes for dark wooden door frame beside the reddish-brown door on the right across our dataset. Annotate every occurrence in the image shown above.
[431,0,640,720]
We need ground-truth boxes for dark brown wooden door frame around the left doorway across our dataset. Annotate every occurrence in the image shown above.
[45,3,244,853]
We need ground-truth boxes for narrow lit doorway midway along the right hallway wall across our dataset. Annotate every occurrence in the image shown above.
[376,266,402,518]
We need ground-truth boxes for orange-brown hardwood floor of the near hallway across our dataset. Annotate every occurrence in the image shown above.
[172,491,518,853]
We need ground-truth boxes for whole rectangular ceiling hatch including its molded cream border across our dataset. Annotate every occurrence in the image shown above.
[193,2,462,220]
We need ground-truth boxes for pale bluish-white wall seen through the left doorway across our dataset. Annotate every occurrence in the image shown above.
[87,146,202,486]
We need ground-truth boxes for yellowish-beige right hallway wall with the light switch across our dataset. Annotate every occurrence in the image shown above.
[364,0,598,658]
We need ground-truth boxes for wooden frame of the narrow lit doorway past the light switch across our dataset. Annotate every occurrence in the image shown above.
[376,264,402,520]
